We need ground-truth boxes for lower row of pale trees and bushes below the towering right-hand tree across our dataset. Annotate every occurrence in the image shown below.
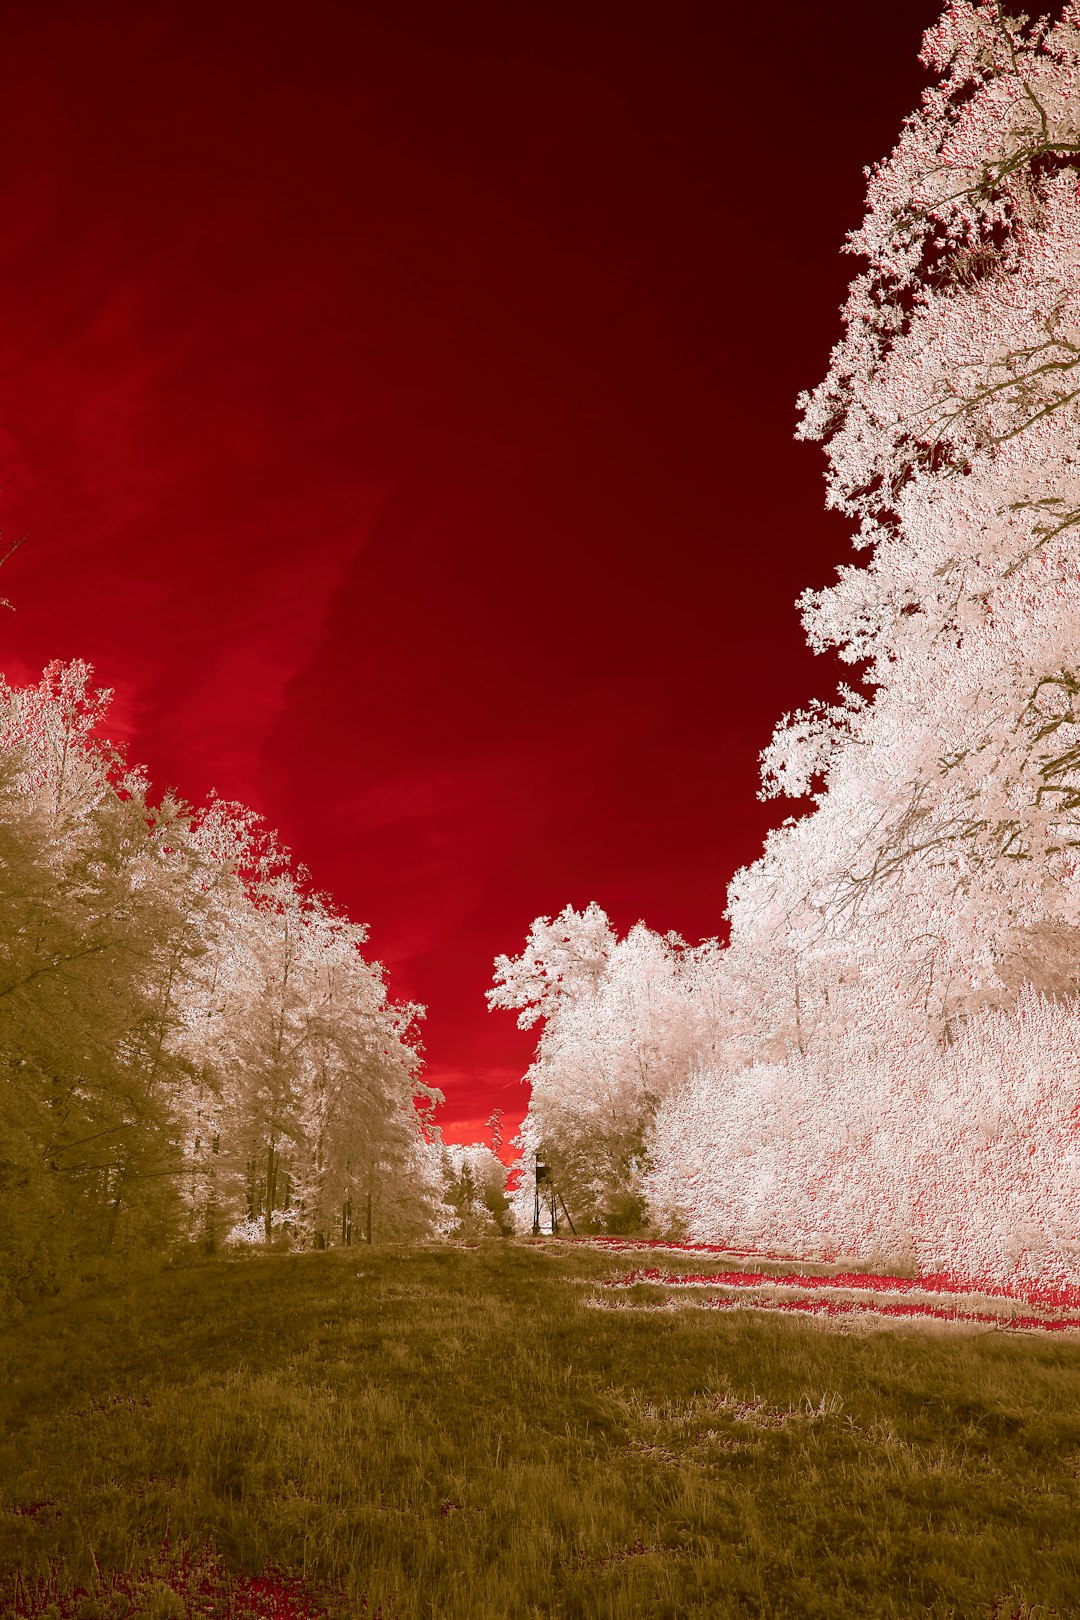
[491,906,1080,1281]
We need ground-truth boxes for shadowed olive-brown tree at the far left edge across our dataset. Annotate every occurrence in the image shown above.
[0,664,201,1286]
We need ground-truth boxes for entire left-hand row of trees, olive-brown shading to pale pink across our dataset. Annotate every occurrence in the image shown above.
[0,663,457,1298]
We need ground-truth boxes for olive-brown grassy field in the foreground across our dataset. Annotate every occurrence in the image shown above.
[0,1241,1080,1620]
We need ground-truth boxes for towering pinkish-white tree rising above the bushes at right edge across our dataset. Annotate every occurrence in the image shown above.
[751,0,1080,1001]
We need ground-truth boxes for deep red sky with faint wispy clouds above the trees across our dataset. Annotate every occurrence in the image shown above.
[0,0,938,1140]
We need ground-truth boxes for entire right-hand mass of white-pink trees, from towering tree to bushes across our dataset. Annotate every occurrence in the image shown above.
[491,0,1080,1281]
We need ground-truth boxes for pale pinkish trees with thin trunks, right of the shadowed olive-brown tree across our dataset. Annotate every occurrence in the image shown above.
[177,802,442,1246]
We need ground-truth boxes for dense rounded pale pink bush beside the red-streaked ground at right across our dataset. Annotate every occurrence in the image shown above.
[646,990,1080,1286]
